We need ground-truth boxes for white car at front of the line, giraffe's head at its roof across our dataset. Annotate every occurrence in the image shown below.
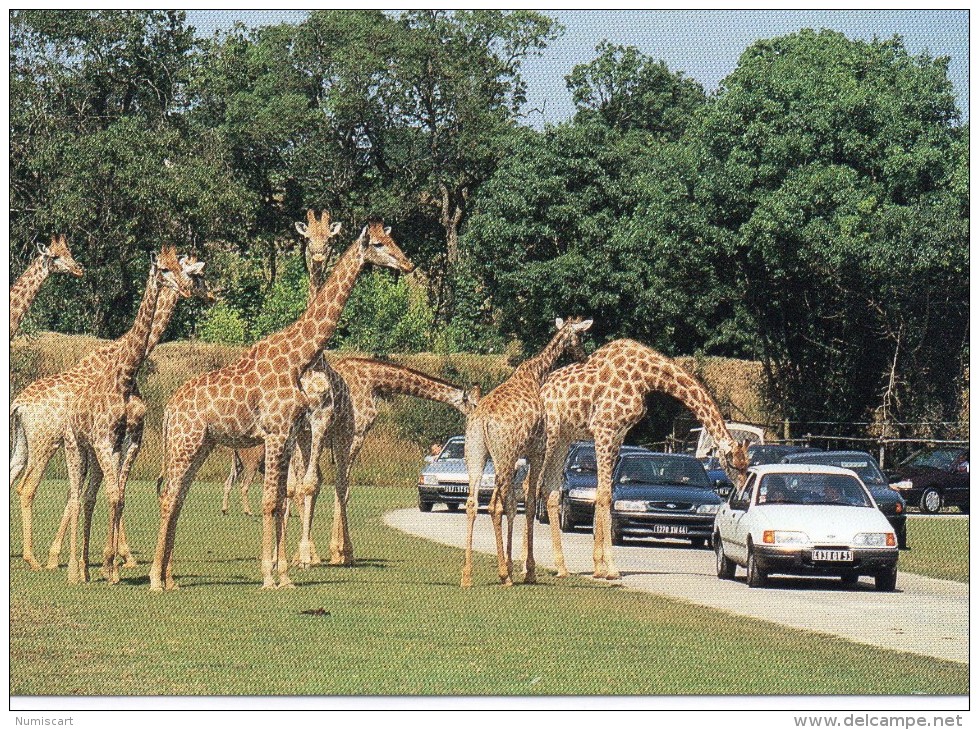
[714,464,898,591]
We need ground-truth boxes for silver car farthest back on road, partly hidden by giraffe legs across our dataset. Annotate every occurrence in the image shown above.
[418,436,527,512]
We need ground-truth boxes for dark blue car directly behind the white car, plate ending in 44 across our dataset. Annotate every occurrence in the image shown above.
[612,452,723,547]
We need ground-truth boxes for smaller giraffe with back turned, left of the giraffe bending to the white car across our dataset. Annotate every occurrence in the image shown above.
[462,318,592,588]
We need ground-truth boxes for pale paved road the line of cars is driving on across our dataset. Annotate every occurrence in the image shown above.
[384,507,969,663]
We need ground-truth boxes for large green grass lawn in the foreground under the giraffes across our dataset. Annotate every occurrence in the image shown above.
[10,481,969,695]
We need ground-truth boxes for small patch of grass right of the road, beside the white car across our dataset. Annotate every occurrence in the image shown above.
[899,517,969,583]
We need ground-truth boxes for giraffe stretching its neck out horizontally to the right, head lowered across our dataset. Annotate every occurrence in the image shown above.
[290,357,479,567]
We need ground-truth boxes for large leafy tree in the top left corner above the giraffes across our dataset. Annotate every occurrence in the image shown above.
[10,11,253,336]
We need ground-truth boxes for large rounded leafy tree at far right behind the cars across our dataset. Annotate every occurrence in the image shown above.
[699,31,968,430]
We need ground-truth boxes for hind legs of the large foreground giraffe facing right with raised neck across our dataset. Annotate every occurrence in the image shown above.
[150,428,213,591]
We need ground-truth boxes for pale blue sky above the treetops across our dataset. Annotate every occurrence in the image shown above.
[187,10,969,127]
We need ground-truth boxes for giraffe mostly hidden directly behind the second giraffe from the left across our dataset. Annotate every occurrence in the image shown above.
[46,256,216,570]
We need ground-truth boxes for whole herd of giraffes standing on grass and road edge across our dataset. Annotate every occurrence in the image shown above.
[10,210,747,591]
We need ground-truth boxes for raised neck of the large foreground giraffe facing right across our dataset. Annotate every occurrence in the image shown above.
[278,240,364,382]
